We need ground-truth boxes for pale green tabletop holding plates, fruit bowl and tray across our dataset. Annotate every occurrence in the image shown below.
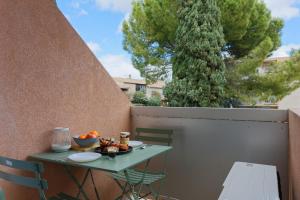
[30,145,172,172]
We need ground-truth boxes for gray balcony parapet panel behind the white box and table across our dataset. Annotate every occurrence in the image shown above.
[132,107,288,200]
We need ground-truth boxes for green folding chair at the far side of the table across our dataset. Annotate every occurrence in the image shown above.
[112,128,173,200]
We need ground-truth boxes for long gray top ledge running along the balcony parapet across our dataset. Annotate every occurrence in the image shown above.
[131,106,288,122]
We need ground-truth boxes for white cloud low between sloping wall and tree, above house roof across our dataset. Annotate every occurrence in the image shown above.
[99,54,141,79]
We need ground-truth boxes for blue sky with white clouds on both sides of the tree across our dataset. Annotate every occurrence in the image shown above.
[56,0,300,78]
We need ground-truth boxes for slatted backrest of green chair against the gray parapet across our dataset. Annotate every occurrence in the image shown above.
[135,128,173,146]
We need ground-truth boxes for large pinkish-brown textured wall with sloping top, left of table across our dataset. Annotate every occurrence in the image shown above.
[0,0,130,200]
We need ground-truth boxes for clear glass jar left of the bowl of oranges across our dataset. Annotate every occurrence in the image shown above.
[51,127,71,152]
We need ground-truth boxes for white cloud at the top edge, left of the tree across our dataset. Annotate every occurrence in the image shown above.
[95,0,132,13]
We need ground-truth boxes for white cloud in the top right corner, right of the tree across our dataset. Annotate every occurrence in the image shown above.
[263,0,300,20]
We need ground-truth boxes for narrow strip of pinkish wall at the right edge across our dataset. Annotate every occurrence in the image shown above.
[289,109,300,200]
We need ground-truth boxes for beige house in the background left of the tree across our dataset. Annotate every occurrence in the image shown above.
[114,76,165,99]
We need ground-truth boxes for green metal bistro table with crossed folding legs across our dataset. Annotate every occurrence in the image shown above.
[30,145,172,200]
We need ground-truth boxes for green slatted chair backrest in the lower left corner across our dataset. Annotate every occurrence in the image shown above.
[0,156,48,200]
